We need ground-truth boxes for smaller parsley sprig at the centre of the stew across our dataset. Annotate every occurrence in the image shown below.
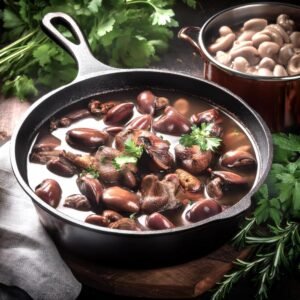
[113,139,144,170]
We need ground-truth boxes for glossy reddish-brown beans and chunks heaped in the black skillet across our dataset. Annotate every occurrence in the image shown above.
[30,91,256,231]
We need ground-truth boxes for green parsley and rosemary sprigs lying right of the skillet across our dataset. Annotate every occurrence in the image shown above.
[212,134,300,300]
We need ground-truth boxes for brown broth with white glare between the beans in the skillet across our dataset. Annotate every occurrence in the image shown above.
[27,90,256,227]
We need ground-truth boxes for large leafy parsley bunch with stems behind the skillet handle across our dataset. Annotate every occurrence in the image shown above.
[0,0,196,99]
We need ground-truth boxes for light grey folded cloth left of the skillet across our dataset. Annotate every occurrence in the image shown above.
[0,143,81,300]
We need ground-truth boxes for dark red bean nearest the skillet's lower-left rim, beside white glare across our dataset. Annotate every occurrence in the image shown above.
[35,179,62,207]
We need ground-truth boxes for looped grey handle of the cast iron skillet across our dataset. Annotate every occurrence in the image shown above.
[41,12,114,81]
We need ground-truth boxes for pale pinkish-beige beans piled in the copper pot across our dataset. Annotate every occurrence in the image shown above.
[208,14,300,77]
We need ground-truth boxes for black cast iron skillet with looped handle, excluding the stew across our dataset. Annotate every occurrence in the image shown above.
[11,13,272,266]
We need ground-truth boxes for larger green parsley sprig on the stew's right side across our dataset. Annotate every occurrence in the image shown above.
[179,123,222,151]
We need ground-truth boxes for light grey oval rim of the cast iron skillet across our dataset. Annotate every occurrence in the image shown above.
[10,68,273,238]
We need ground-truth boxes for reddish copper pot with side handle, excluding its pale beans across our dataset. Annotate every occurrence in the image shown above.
[178,2,300,131]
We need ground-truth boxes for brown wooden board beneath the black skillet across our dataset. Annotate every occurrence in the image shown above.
[62,245,249,299]
